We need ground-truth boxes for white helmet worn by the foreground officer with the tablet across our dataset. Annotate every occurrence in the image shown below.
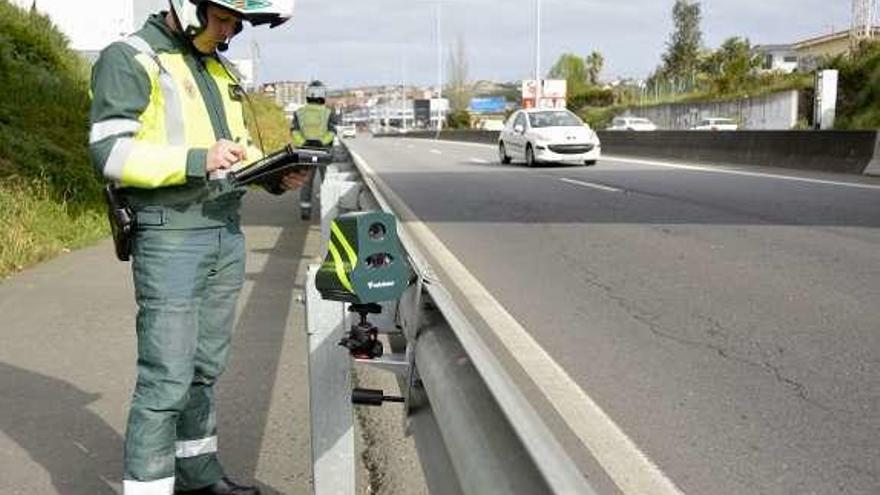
[170,0,294,36]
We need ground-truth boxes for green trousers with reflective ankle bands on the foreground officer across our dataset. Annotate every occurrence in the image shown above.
[124,223,245,495]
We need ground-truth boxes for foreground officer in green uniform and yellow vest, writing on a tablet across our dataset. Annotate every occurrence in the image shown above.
[89,0,306,495]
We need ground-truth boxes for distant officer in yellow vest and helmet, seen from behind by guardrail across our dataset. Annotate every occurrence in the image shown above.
[290,81,336,220]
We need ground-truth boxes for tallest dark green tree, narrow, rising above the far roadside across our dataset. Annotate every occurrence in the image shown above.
[660,0,703,87]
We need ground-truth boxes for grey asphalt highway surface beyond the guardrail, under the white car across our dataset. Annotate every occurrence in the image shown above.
[348,136,880,495]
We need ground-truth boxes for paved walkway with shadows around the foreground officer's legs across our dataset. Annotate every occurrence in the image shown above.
[0,193,320,495]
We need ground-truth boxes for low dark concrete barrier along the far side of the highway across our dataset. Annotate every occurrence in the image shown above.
[384,130,880,176]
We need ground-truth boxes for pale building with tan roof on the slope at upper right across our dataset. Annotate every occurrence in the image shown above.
[755,27,880,72]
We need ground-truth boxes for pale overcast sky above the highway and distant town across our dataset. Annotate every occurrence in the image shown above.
[230,0,851,87]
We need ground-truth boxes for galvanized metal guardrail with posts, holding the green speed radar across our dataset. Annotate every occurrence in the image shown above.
[306,144,595,495]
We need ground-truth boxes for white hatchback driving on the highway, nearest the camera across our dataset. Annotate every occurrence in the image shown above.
[498,108,602,167]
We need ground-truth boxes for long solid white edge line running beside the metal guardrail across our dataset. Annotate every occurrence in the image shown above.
[352,147,683,495]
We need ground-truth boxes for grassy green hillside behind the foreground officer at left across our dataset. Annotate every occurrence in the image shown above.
[0,0,287,279]
